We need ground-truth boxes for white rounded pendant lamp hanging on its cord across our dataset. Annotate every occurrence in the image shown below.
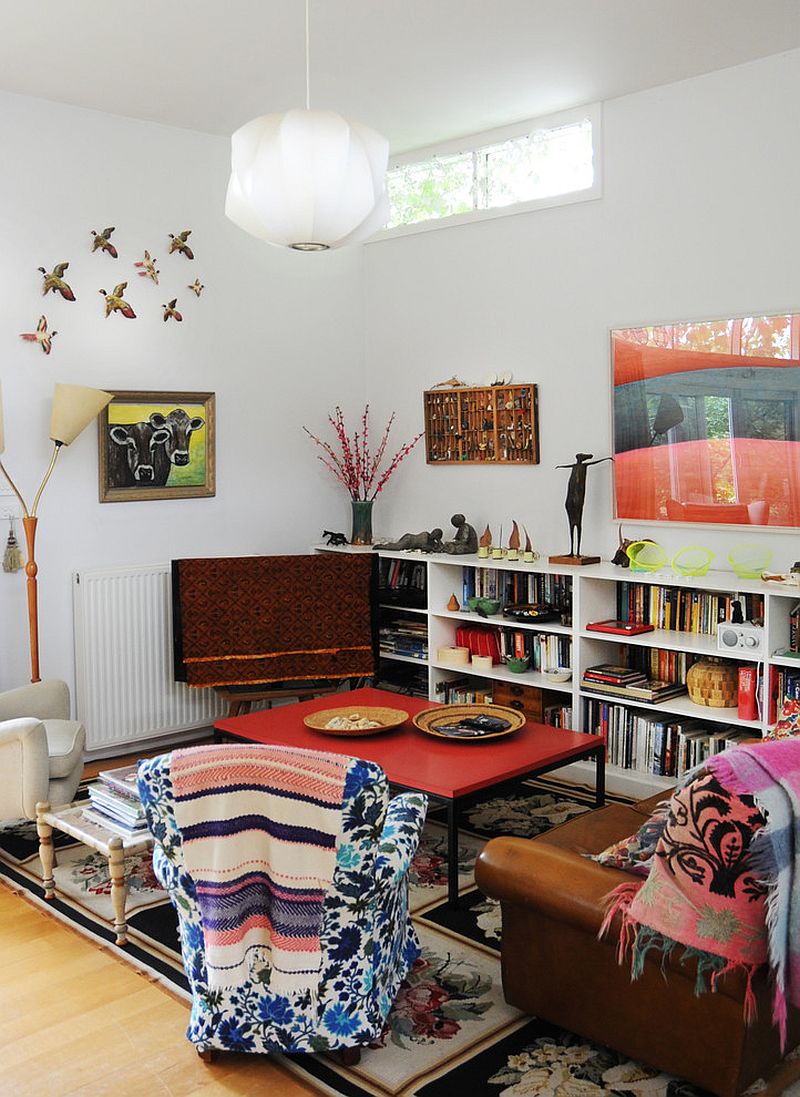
[225,0,388,251]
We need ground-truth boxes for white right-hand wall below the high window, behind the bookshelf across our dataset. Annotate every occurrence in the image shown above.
[365,52,800,569]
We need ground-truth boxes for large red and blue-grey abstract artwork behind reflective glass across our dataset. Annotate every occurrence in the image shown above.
[611,314,800,528]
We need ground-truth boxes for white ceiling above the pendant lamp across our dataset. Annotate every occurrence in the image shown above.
[0,0,800,152]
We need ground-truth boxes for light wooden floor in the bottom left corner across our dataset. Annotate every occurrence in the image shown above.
[0,759,319,1097]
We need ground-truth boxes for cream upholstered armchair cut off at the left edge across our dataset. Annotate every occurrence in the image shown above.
[0,679,86,819]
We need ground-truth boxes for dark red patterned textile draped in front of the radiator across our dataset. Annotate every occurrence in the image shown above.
[172,553,376,687]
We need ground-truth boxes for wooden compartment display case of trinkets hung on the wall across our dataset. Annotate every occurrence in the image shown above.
[422,385,539,465]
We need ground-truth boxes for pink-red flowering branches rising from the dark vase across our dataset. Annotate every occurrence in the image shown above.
[303,404,425,500]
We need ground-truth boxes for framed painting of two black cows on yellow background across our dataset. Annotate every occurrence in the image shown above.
[98,389,216,502]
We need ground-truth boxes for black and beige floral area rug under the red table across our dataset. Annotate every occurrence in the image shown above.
[0,779,724,1097]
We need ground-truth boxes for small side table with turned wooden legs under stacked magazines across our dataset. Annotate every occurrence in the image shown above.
[36,801,154,945]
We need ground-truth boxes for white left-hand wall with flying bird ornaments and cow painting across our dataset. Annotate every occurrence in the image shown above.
[0,94,364,688]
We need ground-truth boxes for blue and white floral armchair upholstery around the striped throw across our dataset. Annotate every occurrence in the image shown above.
[138,754,427,1052]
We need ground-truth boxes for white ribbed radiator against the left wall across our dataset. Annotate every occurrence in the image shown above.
[72,564,227,750]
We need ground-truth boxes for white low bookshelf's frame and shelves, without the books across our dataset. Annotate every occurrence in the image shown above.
[317,545,800,795]
